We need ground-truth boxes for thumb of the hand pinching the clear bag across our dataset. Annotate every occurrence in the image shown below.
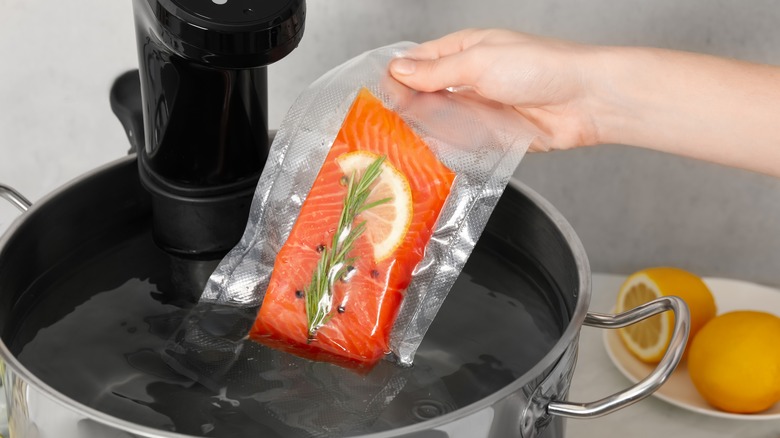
[390,52,476,91]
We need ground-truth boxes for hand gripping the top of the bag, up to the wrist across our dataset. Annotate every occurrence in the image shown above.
[390,29,599,149]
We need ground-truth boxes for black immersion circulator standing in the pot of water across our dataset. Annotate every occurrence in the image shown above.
[133,0,306,256]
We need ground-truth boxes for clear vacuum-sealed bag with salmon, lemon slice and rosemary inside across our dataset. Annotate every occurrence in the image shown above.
[168,43,538,380]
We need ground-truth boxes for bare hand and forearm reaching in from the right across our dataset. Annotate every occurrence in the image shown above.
[390,30,780,177]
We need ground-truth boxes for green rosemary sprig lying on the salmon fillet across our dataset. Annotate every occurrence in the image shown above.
[304,156,392,342]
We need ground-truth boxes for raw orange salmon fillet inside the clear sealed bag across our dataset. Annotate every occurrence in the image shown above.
[249,89,455,369]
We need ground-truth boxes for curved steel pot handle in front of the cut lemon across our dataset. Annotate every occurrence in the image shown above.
[547,296,690,418]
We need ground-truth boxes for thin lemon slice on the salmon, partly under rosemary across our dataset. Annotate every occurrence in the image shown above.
[336,151,413,261]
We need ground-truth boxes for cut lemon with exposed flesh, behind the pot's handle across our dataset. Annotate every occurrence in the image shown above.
[616,267,716,363]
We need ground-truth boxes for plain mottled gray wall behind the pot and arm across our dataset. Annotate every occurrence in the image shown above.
[0,0,780,286]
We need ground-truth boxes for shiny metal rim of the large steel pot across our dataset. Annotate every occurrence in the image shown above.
[0,154,591,438]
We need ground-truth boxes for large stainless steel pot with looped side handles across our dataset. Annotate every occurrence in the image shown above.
[0,156,689,438]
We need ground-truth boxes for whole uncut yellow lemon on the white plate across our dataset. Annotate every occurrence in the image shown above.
[688,311,780,414]
